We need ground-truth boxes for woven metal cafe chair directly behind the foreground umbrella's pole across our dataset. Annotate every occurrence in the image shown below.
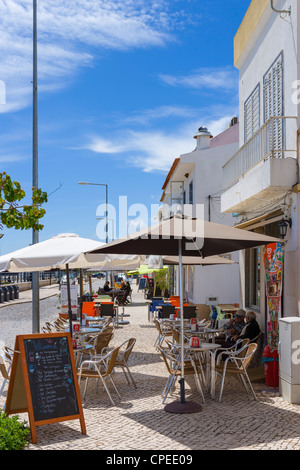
[158,346,205,403]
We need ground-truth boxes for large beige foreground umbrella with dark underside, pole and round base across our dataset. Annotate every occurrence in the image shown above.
[86,214,282,413]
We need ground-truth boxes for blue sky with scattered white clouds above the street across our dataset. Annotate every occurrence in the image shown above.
[0,0,251,254]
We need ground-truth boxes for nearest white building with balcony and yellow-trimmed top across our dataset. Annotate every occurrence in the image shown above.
[221,0,300,336]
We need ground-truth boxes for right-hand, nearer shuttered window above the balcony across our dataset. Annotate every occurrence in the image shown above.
[264,52,284,157]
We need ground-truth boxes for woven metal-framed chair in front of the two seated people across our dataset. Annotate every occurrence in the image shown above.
[216,343,257,402]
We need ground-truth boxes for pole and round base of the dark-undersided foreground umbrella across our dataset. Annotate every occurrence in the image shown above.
[165,239,202,414]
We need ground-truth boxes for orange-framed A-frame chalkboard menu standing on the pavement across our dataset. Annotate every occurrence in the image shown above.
[5,333,86,443]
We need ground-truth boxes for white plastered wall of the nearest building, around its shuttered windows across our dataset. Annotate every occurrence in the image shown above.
[237,0,300,316]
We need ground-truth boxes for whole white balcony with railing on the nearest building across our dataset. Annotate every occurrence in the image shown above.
[221,117,297,213]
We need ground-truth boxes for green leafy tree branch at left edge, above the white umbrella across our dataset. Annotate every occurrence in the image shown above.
[0,172,47,231]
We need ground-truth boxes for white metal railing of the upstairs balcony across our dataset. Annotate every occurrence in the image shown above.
[223,116,297,191]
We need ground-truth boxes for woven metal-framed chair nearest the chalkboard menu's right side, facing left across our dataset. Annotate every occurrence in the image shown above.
[78,347,121,405]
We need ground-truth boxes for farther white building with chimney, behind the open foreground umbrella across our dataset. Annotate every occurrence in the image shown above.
[161,118,239,316]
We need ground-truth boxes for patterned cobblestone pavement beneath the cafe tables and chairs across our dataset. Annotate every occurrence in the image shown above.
[0,284,300,451]
